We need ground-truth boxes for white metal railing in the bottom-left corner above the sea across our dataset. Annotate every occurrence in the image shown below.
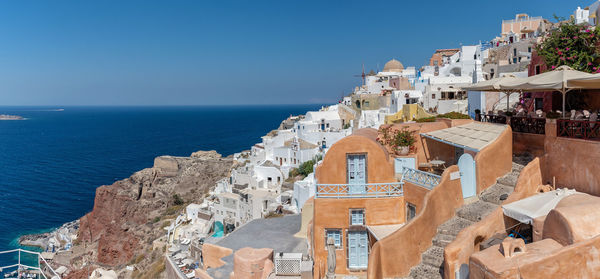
[0,249,61,279]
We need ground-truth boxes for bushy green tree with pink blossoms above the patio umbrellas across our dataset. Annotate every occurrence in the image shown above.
[535,20,600,73]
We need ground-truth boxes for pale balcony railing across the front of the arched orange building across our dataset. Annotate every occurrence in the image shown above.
[315,182,404,199]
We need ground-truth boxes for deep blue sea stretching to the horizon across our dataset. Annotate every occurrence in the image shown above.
[0,105,321,266]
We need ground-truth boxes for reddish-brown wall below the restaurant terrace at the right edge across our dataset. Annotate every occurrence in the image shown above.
[543,122,600,196]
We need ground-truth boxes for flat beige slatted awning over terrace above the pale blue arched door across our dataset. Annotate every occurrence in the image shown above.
[421,122,507,152]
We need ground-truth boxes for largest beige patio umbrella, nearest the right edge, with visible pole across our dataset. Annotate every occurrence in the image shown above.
[500,66,594,116]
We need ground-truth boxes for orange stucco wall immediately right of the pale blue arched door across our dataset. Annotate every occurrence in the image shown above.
[475,126,512,194]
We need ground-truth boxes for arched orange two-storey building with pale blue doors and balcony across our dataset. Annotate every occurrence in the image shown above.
[311,128,405,278]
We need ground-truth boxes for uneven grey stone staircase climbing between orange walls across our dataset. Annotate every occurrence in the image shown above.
[407,155,533,279]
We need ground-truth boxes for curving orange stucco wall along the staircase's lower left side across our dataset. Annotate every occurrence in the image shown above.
[367,165,463,278]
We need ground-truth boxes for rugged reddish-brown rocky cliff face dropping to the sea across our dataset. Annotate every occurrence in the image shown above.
[72,151,233,268]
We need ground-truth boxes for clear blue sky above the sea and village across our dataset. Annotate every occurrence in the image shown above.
[0,0,593,106]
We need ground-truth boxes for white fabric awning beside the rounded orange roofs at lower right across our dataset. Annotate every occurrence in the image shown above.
[502,189,577,224]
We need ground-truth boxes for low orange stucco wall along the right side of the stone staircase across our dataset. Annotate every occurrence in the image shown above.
[444,158,542,279]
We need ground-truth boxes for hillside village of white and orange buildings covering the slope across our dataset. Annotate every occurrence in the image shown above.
[9,1,600,278]
